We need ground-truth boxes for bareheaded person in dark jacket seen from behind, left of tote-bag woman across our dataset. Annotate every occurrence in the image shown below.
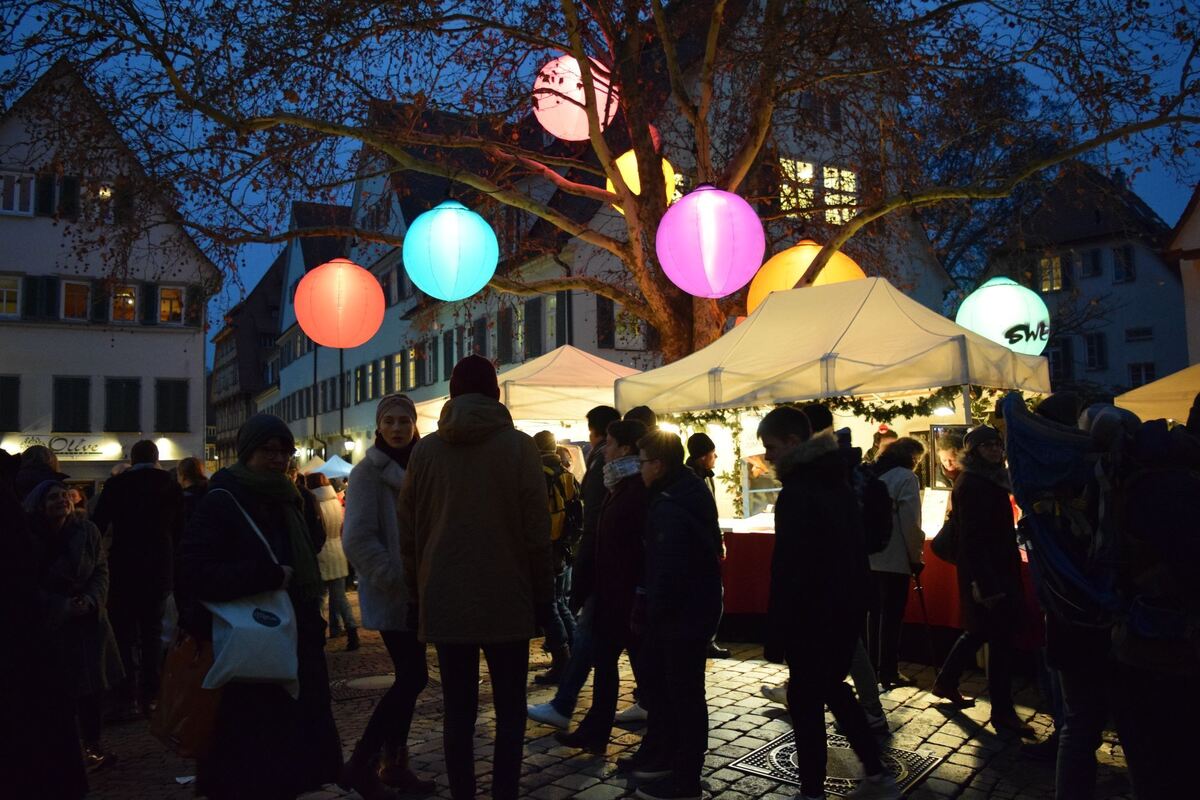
[92,439,184,714]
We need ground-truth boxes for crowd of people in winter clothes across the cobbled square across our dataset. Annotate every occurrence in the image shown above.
[0,356,1200,800]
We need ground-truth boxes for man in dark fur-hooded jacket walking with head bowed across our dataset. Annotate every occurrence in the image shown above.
[758,407,900,798]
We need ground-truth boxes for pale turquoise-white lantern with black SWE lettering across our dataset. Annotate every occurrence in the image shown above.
[954,278,1050,355]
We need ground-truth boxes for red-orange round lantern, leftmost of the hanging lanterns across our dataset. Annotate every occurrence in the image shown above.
[294,258,386,348]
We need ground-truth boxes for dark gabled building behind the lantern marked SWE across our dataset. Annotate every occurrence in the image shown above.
[1001,163,1188,398]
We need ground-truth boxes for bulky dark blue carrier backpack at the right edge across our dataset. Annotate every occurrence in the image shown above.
[1001,393,1200,664]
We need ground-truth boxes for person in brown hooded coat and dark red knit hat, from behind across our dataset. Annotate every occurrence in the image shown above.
[400,355,554,800]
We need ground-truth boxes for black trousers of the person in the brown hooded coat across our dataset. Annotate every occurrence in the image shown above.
[437,639,529,800]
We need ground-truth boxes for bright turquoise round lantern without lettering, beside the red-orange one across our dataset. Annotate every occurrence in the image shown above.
[403,200,500,302]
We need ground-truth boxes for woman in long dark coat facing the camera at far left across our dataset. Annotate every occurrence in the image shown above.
[25,481,125,770]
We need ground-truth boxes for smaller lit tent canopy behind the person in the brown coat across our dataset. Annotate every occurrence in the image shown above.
[416,344,638,431]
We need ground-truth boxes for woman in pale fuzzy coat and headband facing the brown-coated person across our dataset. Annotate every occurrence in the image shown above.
[342,393,437,800]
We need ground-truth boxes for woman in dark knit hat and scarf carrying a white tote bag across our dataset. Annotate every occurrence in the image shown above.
[175,414,342,800]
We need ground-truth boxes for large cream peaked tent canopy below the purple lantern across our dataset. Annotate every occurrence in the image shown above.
[617,278,1050,414]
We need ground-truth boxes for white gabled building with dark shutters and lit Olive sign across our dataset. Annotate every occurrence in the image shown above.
[0,62,220,482]
